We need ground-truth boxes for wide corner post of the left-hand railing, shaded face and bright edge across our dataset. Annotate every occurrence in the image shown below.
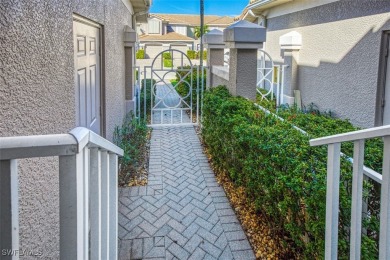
[59,149,88,260]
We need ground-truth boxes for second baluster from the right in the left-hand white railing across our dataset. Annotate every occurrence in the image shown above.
[101,151,110,259]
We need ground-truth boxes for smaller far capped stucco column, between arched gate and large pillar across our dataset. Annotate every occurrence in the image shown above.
[203,29,225,88]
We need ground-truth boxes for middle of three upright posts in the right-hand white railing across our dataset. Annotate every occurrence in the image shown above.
[350,140,364,259]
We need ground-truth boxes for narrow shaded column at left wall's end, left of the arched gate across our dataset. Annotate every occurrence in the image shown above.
[123,26,137,113]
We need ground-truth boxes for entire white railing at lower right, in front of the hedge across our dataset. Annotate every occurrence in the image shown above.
[310,126,390,259]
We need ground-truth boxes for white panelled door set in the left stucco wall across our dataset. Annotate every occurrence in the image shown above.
[73,18,101,134]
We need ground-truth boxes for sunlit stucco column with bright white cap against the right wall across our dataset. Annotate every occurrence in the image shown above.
[279,31,302,106]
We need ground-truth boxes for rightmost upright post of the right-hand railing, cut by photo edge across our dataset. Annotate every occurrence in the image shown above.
[379,136,390,259]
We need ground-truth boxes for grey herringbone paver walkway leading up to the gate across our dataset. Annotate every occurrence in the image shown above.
[119,127,255,259]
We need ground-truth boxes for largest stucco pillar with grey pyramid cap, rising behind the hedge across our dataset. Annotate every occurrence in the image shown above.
[223,21,266,100]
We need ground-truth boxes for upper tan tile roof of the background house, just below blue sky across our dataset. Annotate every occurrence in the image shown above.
[150,13,235,26]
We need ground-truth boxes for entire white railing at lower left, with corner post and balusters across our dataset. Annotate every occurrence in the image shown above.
[0,127,123,259]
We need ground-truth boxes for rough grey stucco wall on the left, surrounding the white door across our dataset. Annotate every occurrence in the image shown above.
[0,0,132,258]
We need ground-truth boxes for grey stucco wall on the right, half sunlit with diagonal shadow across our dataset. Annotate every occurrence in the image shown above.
[266,0,390,127]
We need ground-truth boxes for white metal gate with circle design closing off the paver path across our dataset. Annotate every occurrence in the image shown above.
[140,49,204,126]
